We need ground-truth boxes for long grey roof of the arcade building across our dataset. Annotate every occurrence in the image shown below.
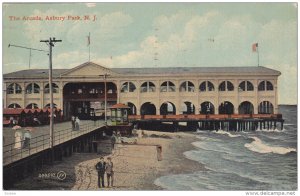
[3,63,281,79]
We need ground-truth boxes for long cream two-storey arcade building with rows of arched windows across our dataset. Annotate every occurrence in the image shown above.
[3,62,281,119]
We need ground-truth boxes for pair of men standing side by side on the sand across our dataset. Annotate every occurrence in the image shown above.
[95,157,114,188]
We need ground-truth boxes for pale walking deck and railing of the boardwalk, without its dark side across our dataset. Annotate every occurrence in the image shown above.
[3,120,104,165]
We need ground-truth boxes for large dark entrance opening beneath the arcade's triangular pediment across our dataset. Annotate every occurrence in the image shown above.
[63,82,117,120]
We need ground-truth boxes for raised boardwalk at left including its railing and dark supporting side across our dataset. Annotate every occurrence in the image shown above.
[3,120,106,190]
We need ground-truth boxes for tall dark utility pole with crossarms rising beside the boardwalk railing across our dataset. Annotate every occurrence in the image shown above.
[40,37,62,163]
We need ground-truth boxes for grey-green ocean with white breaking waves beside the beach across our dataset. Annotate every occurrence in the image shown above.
[155,105,298,191]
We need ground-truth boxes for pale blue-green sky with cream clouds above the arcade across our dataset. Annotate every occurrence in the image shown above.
[2,3,298,104]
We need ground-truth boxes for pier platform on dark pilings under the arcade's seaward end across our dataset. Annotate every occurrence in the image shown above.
[128,114,284,131]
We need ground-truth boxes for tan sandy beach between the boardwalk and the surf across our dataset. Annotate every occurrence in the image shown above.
[14,131,204,190]
